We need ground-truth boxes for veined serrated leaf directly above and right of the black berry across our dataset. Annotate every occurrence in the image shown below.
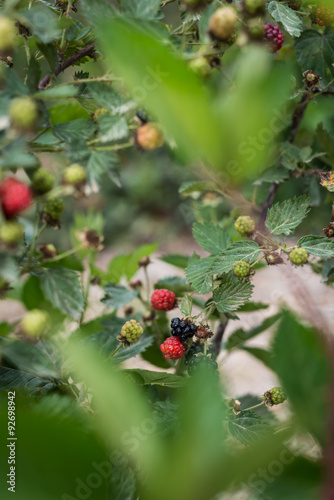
[212,273,254,313]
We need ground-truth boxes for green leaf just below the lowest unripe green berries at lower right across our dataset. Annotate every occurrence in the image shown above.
[228,411,270,445]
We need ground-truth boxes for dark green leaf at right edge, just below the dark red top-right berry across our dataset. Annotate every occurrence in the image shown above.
[295,28,334,84]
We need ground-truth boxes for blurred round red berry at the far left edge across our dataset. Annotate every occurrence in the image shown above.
[0,177,32,218]
